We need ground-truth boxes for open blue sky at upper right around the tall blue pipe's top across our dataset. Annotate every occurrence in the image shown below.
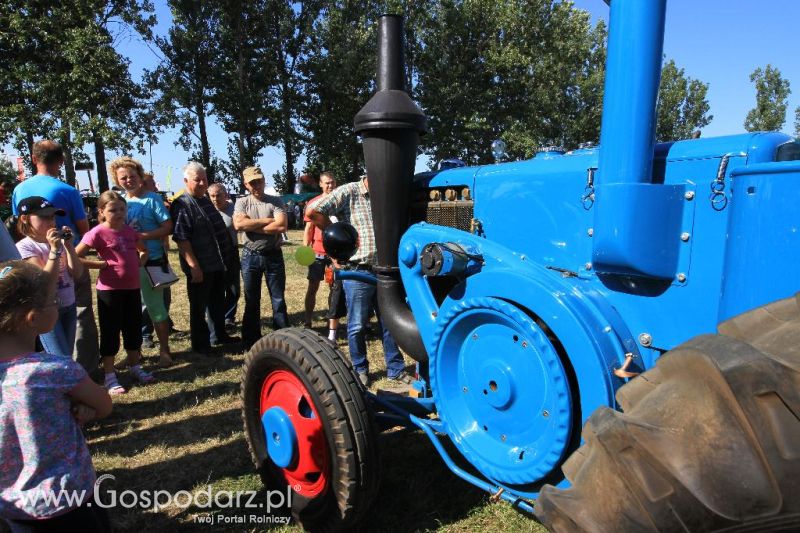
[574,0,800,137]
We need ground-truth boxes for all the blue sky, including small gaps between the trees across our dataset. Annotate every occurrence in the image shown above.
[6,0,800,190]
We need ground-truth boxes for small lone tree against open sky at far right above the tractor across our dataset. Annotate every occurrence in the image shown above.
[744,65,792,131]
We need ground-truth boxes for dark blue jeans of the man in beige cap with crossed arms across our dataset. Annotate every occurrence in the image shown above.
[242,247,289,349]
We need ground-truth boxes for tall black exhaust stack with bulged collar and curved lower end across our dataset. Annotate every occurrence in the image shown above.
[353,15,428,361]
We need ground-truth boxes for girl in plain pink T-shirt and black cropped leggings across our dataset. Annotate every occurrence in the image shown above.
[76,191,153,394]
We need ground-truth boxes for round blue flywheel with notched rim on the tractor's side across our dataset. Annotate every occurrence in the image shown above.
[430,297,572,485]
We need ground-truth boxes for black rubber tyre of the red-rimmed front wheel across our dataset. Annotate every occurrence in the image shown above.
[241,328,380,531]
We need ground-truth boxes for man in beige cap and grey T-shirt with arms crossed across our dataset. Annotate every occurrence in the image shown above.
[233,167,289,349]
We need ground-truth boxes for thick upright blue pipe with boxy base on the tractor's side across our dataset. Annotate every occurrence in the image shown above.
[592,0,683,280]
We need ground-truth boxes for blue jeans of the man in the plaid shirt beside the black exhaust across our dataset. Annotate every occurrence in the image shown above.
[343,279,405,378]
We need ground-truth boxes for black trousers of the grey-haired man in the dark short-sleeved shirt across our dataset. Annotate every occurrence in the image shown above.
[185,271,225,353]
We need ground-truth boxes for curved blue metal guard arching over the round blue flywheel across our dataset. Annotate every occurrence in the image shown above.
[400,223,630,430]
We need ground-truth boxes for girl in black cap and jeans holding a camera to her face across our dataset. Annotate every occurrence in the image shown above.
[17,196,83,357]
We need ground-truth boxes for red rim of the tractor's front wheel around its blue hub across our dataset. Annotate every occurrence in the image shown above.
[260,370,330,497]
